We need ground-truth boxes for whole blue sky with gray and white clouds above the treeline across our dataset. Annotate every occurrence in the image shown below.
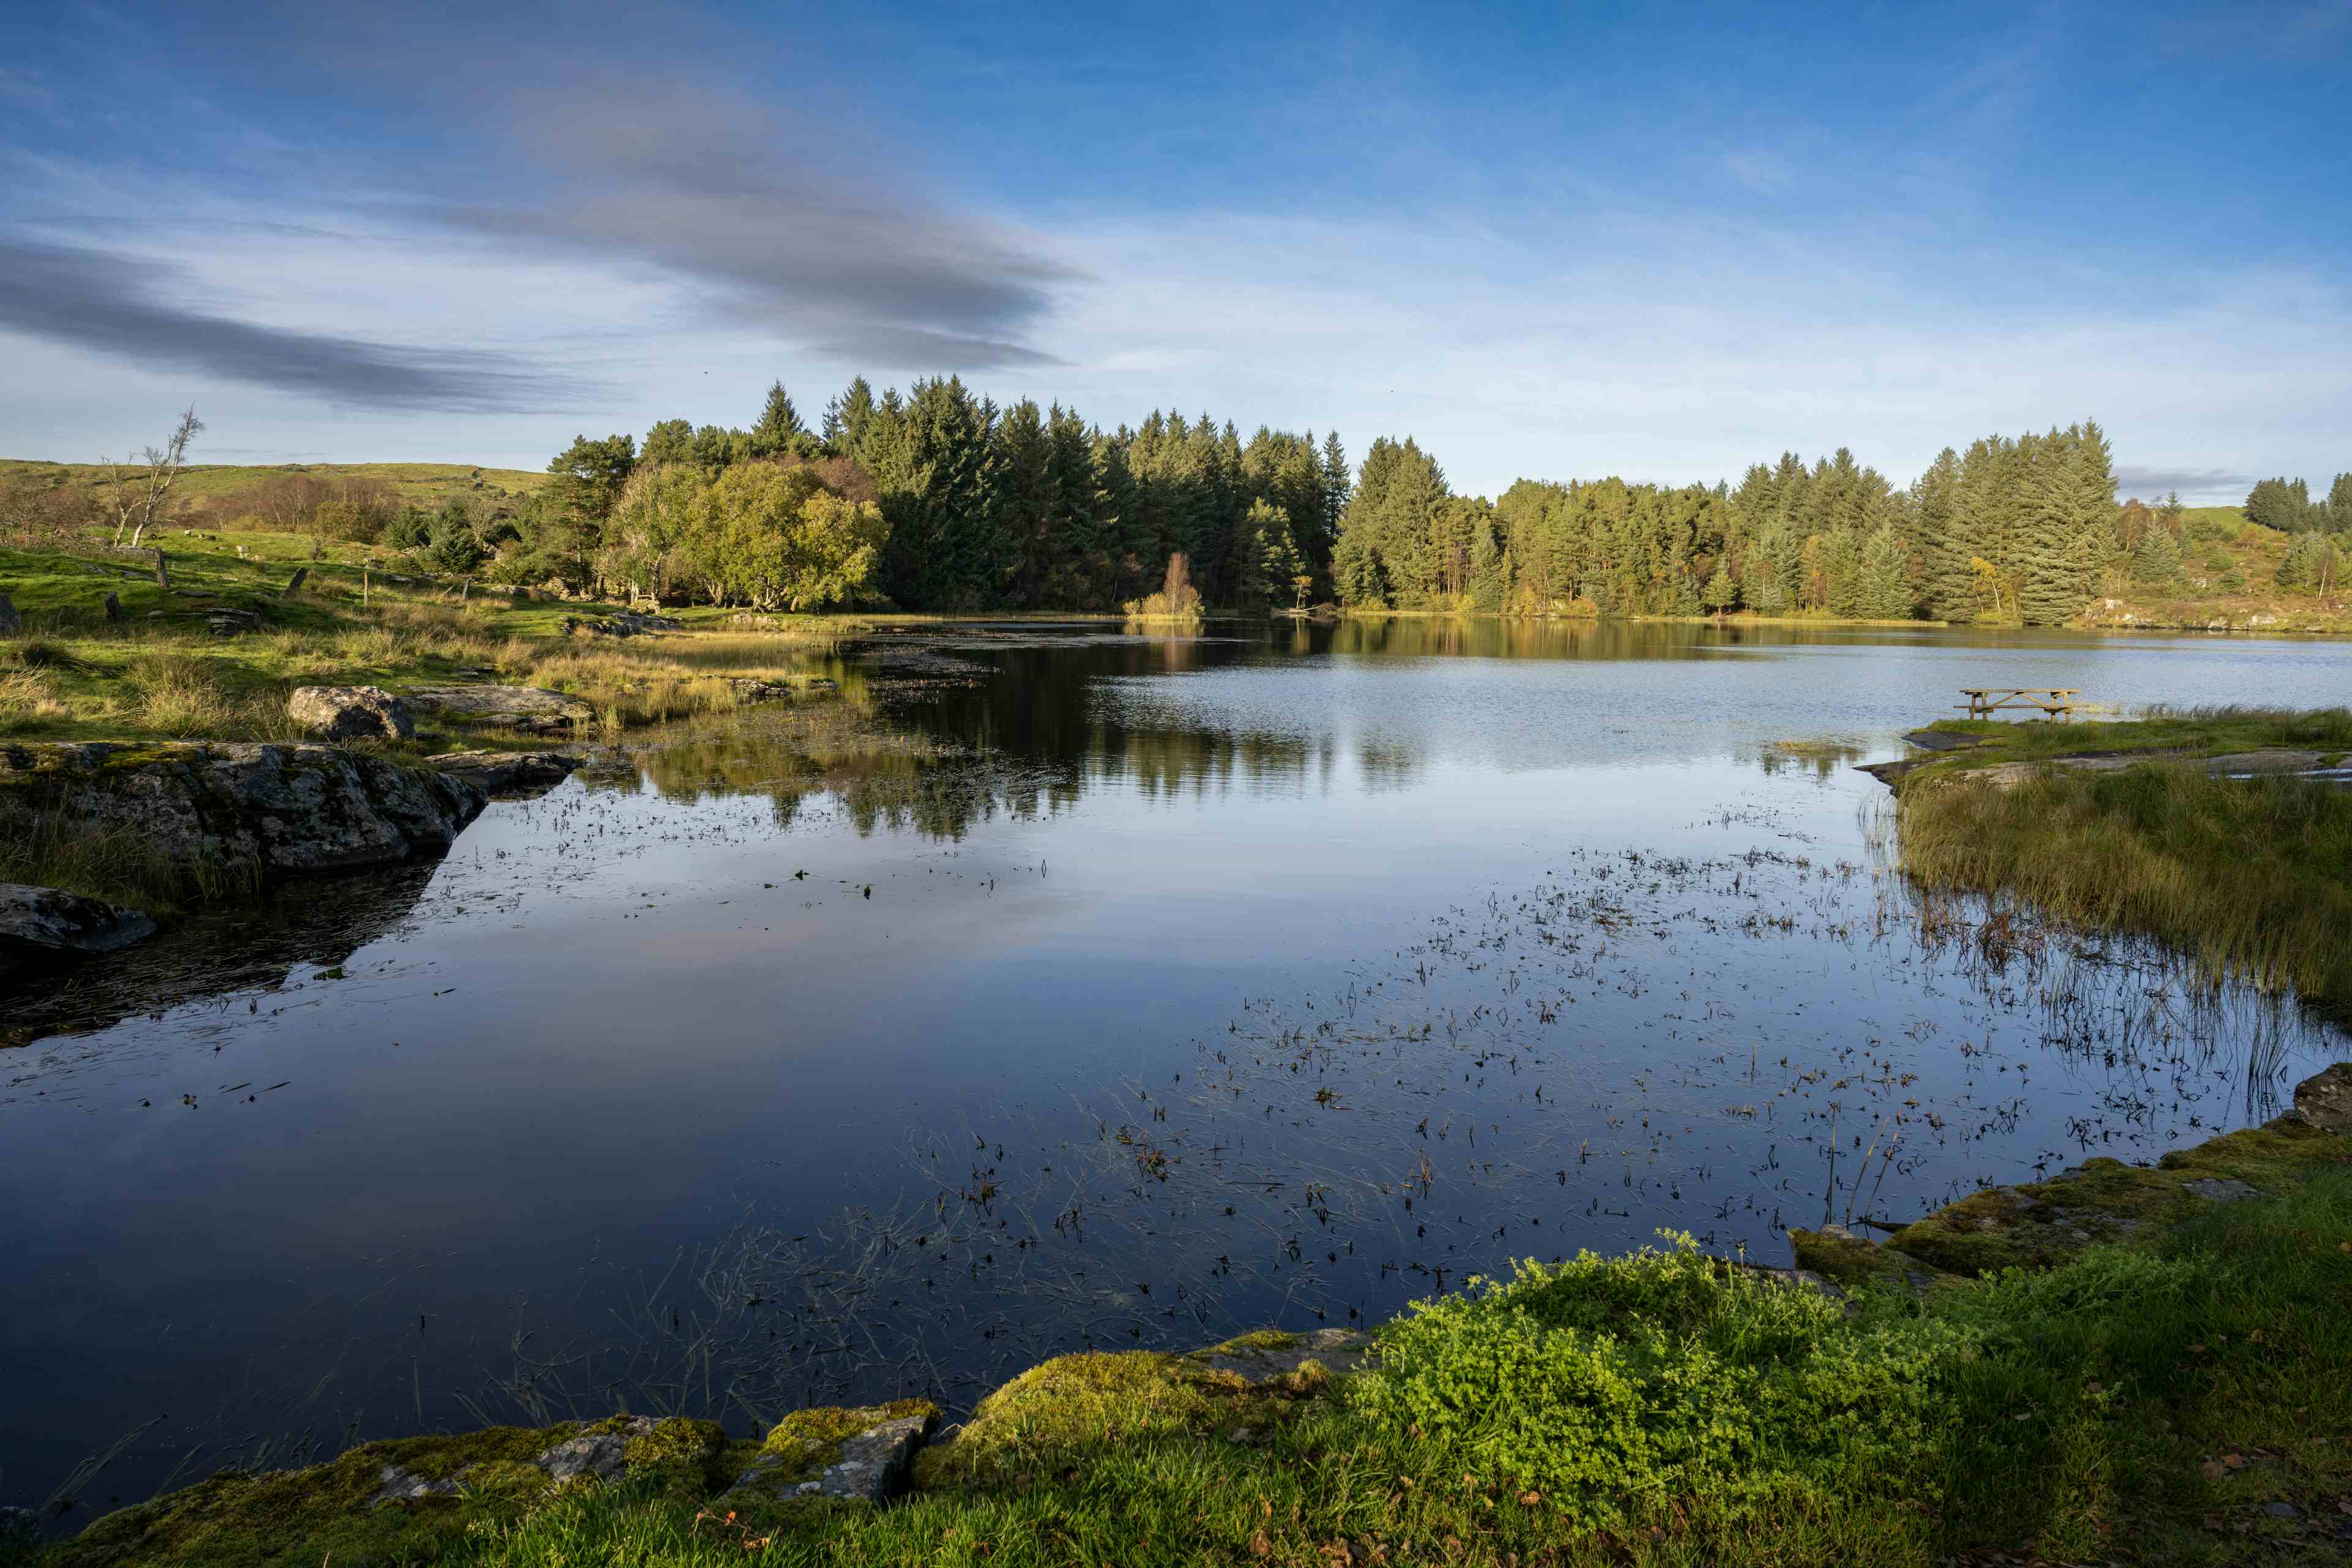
[0,0,2352,501]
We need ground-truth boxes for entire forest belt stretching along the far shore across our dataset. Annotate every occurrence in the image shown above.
[50,376,2352,625]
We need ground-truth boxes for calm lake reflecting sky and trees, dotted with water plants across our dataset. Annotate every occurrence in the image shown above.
[0,618,2352,1517]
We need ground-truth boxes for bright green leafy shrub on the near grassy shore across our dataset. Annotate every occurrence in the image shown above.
[1352,1232,1980,1528]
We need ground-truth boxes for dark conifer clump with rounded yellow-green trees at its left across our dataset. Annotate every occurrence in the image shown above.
[463,376,1348,611]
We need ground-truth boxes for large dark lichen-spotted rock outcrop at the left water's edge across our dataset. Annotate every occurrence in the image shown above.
[0,741,489,872]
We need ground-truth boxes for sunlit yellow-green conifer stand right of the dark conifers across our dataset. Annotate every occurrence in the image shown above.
[1333,423,2145,623]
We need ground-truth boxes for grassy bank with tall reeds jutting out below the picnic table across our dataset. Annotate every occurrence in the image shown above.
[1898,707,2352,1006]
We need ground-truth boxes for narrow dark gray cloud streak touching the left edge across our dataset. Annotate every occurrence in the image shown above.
[0,235,593,414]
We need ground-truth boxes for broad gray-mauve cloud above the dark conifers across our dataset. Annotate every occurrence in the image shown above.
[412,78,1084,369]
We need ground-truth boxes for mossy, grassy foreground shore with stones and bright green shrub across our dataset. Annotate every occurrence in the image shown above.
[18,1065,2352,1568]
